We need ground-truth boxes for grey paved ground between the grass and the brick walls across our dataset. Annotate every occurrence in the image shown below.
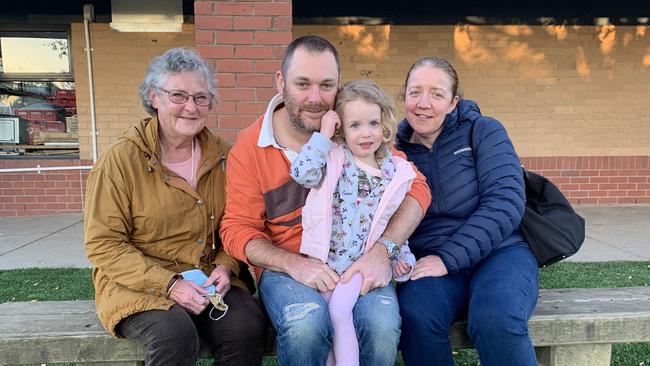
[0,205,650,269]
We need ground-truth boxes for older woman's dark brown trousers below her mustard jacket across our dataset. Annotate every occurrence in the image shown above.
[118,286,266,366]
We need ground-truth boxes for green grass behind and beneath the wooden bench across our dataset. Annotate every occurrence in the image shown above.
[0,262,650,366]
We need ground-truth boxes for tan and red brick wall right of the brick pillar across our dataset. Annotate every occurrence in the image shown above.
[293,25,650,204]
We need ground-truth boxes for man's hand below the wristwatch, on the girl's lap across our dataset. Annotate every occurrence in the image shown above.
[341,244,392,295]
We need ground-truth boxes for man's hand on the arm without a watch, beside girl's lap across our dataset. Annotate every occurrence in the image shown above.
[287,255,339,292]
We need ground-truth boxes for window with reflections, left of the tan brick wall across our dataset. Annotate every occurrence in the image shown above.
[0,30,79,158]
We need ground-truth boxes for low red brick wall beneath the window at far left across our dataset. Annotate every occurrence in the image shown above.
[0,159,92,216]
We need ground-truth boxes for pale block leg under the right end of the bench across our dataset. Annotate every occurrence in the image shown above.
[535,344,612,366]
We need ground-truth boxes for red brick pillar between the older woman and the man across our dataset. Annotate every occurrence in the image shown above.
[194,0,292,141]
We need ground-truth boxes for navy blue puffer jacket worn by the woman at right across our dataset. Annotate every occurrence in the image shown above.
[396,100,526,273]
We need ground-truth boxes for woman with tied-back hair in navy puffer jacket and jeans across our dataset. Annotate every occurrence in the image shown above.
[397,57,538,366]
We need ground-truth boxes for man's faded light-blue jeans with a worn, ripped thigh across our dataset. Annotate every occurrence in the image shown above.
[259,270,401,366]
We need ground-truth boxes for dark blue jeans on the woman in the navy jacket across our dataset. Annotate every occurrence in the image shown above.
[398,245,539,366]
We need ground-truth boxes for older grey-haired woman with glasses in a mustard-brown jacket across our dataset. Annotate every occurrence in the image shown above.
[84,48,265,365]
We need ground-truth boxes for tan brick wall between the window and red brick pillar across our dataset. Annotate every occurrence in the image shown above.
[71,23,194,159]
